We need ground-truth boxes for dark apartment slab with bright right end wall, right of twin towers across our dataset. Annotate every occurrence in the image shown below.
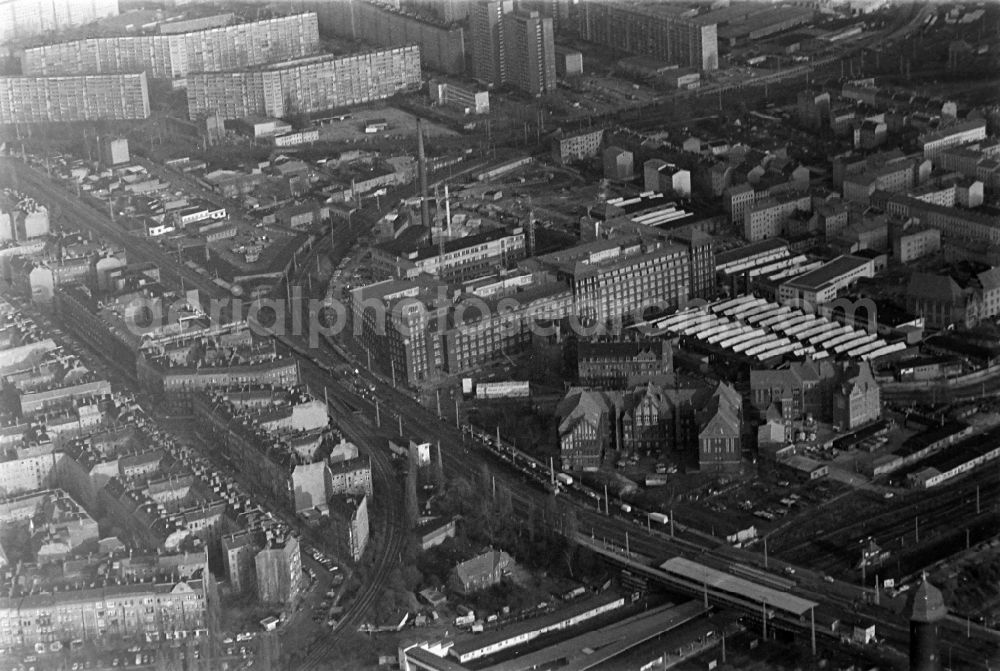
[580,0,719,70]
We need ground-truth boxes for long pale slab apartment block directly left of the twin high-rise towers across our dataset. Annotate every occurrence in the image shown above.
[187,46,421,120]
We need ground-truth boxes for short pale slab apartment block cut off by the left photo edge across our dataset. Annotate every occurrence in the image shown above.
[0,72,149,124]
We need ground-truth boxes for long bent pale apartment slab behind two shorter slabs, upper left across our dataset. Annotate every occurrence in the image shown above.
[21,13,320,79]
